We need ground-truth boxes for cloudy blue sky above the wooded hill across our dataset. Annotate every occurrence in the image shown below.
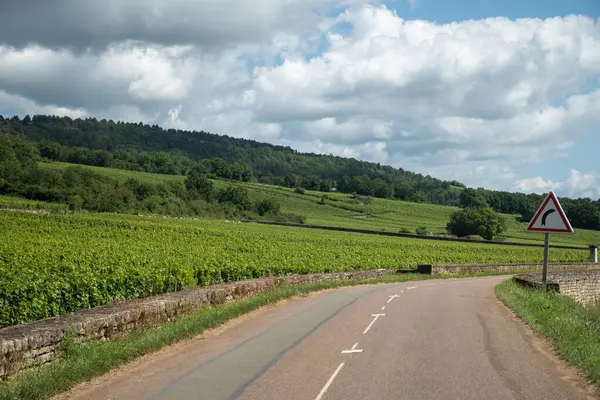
[0,0,600,200]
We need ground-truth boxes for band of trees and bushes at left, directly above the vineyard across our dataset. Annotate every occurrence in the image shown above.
[0,134,304,223]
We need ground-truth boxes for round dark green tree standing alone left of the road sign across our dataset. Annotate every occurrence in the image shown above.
[446,207,507,240]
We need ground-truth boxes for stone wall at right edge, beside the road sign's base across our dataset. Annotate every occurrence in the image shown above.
[515,265,600,306]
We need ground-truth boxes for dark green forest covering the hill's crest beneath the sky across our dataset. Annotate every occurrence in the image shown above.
[0,115,600,230]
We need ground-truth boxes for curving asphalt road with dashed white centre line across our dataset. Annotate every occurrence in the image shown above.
[58,278,595,400]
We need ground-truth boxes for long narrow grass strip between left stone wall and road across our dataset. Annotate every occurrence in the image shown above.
[0,271,536,400]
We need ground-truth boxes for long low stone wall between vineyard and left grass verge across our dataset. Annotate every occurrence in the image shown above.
[0,269,396,380]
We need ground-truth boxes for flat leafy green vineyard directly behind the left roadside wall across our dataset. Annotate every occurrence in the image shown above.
[0,211,587,326]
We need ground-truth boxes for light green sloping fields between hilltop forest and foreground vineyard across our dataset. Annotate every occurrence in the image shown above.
[40,163,600,245]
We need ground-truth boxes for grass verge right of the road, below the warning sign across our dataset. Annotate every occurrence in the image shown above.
[496,279,600,384]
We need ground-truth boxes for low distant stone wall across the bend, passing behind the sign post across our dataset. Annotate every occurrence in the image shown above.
[417,263,600,275]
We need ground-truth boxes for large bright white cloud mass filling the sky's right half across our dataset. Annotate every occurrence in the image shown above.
[247,6,600,191]
